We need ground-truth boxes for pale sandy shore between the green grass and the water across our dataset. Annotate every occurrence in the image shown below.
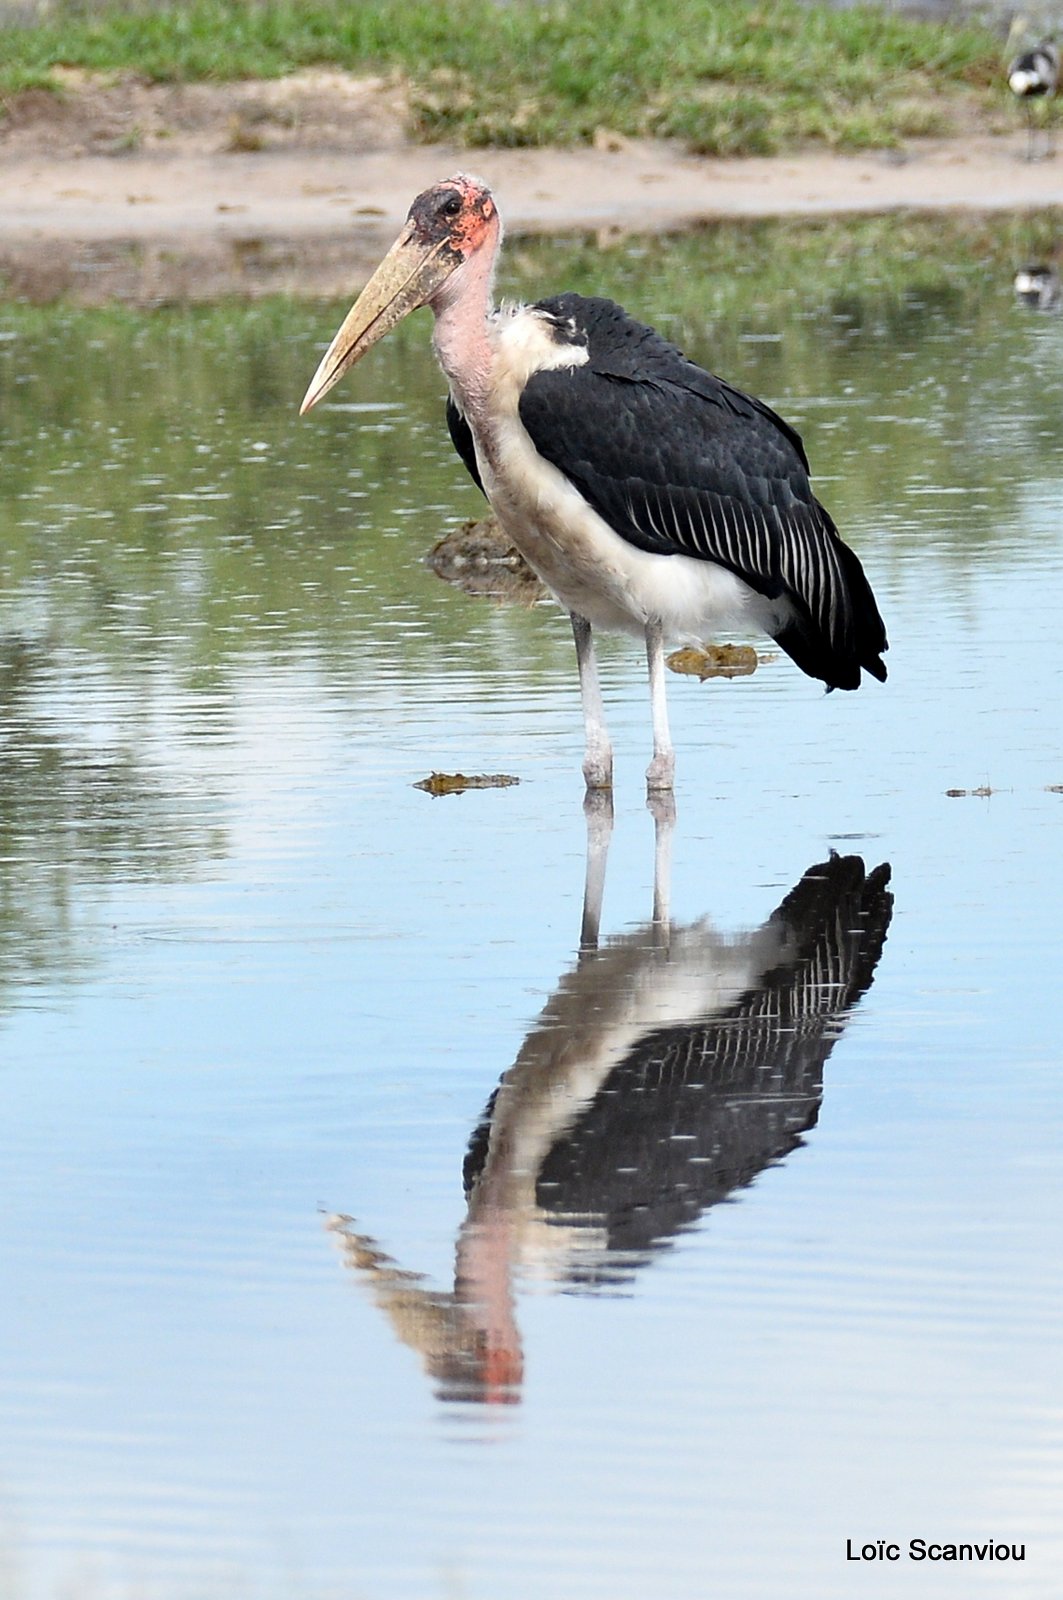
[0,74,1063,299]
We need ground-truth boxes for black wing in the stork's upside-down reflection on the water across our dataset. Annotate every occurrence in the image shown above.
[466,856,893,1282]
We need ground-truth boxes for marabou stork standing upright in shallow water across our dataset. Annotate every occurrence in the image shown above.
[301,174,887,792]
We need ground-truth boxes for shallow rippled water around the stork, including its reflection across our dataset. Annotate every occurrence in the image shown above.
[0,219,1063,1600]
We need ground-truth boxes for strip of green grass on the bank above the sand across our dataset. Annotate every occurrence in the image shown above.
[0,0,1002,154]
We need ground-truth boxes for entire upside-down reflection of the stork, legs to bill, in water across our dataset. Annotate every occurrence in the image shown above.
[330,803,892,1400]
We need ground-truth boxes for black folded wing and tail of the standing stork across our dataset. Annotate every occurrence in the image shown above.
[520,294,887,688]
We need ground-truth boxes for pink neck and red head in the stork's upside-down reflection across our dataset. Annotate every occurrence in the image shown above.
[455,1195,523,1402]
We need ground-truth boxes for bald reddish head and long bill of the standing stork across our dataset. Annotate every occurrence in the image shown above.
[299,176,496,416]
